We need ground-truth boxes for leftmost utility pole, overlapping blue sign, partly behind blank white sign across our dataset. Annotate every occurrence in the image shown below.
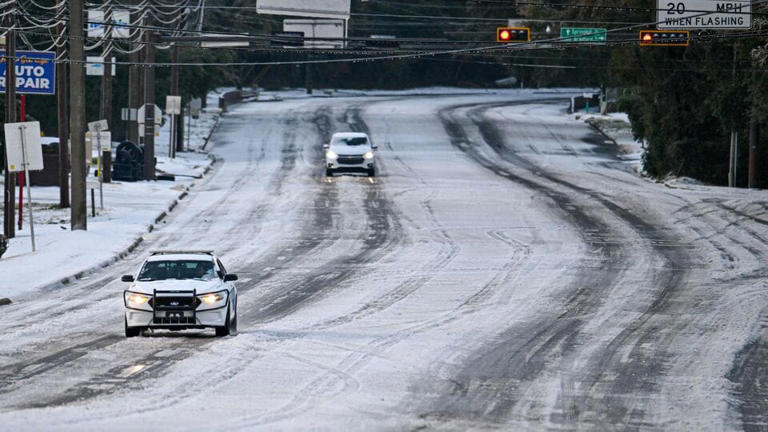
[3,10,16,238]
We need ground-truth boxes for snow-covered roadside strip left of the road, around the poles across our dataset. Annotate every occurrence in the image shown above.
[0,94,219,303]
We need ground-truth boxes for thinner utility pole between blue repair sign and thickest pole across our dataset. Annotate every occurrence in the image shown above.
[56,23,69,208]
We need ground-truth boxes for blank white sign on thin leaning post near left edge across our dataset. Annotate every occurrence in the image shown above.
[5,122,43,252]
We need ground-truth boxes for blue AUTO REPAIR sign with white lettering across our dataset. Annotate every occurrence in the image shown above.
[0,51,56,95]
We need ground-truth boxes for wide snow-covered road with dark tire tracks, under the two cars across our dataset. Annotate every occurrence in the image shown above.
[0,91,768,431]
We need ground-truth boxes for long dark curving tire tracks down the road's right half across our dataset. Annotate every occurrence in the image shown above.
[416,101,684,425]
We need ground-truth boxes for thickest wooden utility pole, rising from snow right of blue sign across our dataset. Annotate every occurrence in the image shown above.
[69,0,88,231]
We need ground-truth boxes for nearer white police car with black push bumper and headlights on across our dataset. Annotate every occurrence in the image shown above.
[122,251,237,337]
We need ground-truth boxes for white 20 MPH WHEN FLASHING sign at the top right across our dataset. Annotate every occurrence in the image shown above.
[656,0,752,30]
